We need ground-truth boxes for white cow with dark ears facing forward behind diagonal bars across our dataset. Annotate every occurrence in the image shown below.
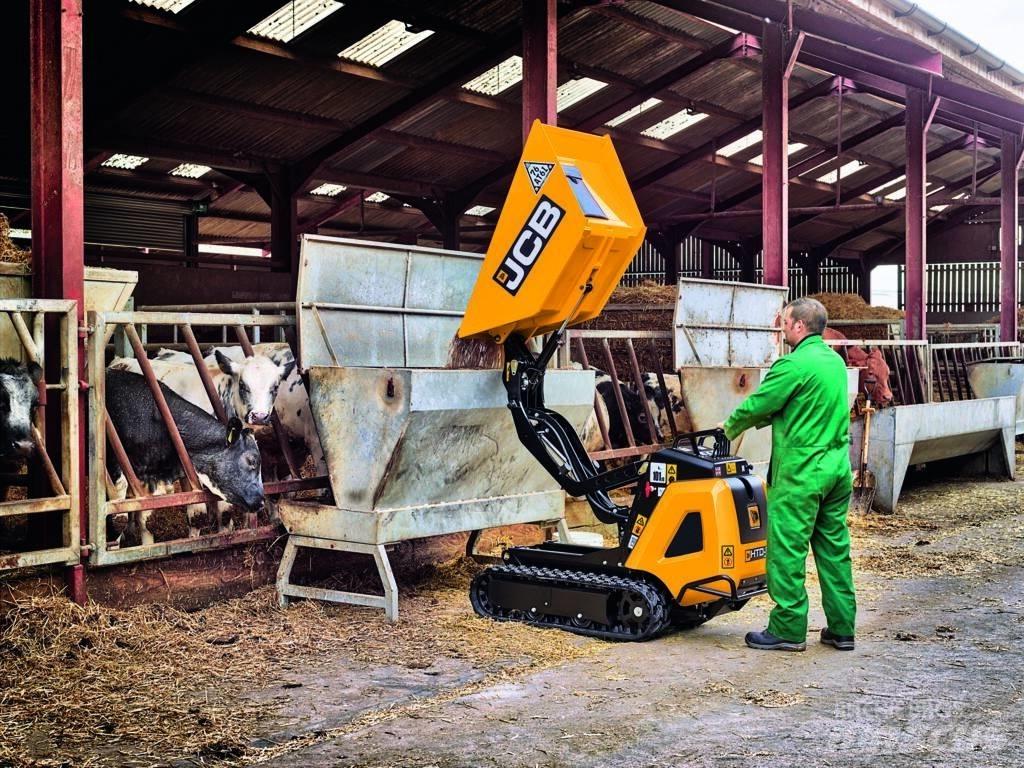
[110,349,295,424]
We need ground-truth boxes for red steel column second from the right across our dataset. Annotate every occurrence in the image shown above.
[903,89,928,339]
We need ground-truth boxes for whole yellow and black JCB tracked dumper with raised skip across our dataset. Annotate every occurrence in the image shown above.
[459,122,768,640]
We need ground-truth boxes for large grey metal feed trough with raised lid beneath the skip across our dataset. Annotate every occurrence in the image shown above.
[278,236,594,621]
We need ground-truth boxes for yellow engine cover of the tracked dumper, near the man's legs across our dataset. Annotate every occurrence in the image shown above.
[626,478,767,606]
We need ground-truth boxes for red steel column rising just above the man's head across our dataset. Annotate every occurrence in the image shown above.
[761,22,790,286]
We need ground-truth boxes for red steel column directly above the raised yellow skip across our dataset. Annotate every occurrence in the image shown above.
[522,0,558,142]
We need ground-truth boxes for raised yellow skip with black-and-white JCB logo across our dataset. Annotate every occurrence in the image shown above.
[459,121,646,342]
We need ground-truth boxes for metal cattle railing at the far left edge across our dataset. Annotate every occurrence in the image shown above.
[0,299,81,571]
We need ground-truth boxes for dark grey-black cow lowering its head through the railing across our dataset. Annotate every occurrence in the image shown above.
[106,370,264,545]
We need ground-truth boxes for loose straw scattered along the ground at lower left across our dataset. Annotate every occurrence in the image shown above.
[0,560,600,768]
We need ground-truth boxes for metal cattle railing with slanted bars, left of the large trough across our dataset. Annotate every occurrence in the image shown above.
[89,311,329,565]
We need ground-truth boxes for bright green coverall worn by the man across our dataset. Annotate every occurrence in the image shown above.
[725,335,857,642]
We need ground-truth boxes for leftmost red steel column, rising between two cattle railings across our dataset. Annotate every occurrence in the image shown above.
[29,0,89,602]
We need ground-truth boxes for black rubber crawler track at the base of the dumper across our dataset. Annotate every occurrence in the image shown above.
[469,564,672,642]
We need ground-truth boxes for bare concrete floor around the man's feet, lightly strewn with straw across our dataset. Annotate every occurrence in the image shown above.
[232,466,1024,768]
